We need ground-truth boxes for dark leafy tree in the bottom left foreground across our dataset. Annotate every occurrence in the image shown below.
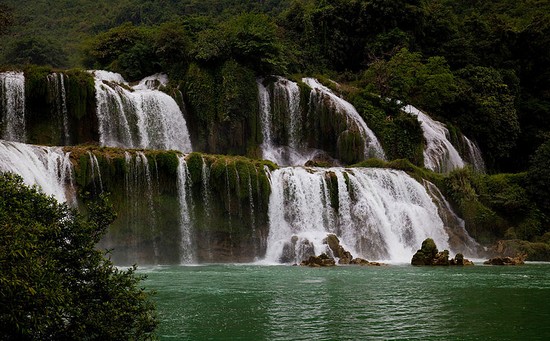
[0,173,157,340]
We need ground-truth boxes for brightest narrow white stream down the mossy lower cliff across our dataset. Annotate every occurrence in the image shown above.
[177,156,196,264]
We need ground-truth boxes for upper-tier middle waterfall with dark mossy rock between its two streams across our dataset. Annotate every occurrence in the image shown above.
[257,77,384,166]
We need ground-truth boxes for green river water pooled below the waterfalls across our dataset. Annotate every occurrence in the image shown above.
[141,263,550,340]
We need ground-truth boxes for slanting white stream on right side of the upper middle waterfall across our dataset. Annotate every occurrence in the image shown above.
[302,78,386,159]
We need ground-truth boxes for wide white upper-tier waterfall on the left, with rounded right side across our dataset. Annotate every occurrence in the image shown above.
[91,70,192,152]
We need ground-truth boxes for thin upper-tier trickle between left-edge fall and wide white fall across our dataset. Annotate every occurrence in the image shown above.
[47,73,71,146]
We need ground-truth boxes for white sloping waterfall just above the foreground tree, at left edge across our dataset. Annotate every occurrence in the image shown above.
[0,140,76,205]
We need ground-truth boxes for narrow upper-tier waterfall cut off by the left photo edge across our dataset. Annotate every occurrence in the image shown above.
[0,71,26,142]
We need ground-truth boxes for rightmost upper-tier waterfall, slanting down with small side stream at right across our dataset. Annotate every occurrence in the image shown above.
[404,105,485,173]
